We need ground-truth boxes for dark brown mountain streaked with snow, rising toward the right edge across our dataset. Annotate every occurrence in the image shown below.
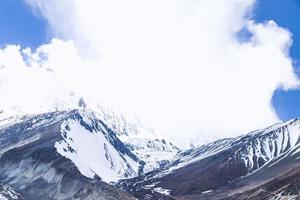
[119,119,300,199]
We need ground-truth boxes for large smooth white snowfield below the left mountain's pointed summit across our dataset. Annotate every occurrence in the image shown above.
[55,110,140,182]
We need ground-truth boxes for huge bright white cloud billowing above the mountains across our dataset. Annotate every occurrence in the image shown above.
[0,0,298,147]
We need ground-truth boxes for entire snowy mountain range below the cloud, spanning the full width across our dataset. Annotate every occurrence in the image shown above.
[0,100,300,200]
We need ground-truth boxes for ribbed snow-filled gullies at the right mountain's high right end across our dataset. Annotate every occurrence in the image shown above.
[232,119,300,172]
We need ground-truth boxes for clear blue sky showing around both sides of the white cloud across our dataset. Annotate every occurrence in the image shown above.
[0,0,300,120]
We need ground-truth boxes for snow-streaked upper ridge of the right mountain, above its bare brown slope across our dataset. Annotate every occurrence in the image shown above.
[157,119,300,177]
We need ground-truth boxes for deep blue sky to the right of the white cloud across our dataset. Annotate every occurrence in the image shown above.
[254,0,300,120]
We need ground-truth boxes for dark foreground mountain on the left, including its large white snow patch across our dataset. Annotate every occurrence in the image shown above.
[0,110,140,199]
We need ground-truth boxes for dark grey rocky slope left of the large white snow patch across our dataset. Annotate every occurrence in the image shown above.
[0,111,134,200]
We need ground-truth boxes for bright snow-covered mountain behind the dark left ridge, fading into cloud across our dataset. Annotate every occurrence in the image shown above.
[0,93,179,175]
